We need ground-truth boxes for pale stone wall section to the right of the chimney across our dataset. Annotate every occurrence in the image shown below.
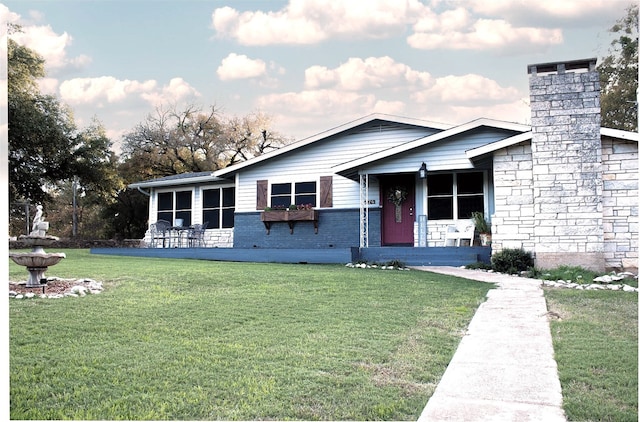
[602,138,638,270]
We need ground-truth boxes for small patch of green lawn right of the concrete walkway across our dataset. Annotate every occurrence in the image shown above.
[545,289,638,422]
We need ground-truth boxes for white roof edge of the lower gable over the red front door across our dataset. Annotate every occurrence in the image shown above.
[333,118,531,175]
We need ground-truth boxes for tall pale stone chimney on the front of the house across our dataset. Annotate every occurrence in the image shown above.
[528,58,605,271]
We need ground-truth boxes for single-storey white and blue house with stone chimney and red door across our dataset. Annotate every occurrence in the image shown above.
[122,59,639,270]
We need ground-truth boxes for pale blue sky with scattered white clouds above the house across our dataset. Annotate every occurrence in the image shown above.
[0,0,632,150]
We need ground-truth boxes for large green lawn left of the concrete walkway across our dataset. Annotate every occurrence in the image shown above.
[9,250,492,420]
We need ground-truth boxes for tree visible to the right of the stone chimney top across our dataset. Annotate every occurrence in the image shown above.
[598,4,638,131]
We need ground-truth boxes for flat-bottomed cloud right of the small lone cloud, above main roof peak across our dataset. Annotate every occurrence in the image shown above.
[305,56,431,91]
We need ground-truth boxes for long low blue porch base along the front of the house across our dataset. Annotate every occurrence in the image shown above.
[91,246,491,267]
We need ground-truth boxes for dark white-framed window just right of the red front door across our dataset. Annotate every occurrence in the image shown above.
[427,172,484,220]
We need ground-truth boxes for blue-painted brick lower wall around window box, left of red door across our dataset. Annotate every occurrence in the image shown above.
[233,209,381,249]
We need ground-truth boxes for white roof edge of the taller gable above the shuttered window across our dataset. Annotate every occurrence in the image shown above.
[214,113,452,177]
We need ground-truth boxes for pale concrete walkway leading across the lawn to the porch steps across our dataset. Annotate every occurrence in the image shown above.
[418,267,566,422]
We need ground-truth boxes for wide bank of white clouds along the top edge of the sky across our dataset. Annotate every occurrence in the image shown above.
[212,0,600,52]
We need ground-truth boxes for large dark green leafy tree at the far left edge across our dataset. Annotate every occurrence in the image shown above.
[7,33,115,208]
